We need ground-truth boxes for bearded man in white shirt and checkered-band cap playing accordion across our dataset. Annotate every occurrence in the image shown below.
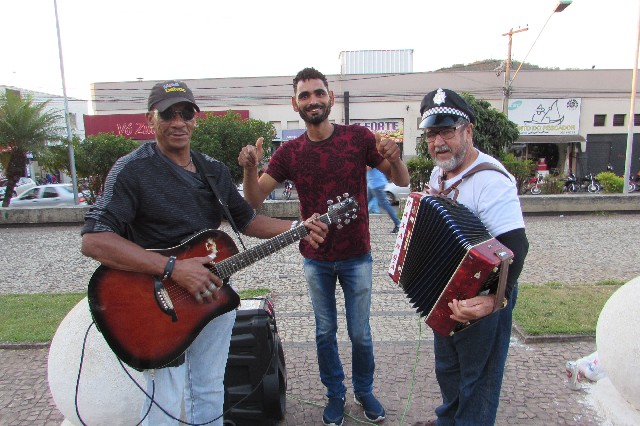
[416,89,529,425]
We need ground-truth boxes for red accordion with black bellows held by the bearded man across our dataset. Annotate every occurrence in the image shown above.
[388,192,513,336]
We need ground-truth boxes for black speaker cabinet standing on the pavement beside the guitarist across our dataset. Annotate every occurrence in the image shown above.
[224,298,287,426]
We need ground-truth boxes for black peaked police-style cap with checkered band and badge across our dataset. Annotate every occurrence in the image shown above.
[418,89,476,129]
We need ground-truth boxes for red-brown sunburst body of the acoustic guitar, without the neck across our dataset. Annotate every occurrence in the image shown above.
[88,230,240,369]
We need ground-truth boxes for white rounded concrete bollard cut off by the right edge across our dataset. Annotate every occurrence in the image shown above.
[596,277,640,412]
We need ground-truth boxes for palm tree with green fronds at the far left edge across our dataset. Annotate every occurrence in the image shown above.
[0,91,62,207]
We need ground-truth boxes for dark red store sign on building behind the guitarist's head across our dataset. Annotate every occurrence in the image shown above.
[84,110,249,141]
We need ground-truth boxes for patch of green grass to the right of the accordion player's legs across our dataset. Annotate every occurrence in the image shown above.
[513,280,624,336]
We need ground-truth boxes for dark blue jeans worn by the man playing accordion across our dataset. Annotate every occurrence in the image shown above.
[434,285,518,426]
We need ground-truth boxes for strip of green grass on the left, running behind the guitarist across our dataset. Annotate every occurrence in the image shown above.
[0,288,271,343]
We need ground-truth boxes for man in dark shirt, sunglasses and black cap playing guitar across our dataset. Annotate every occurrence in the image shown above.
[81,81,327,426]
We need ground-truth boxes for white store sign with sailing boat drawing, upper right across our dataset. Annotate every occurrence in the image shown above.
[509,98,582,136]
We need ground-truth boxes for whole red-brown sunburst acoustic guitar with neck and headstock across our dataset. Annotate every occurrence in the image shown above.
[87,194,358,370]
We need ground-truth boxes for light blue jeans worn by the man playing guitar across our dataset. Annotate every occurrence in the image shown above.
[142,310,236,426]
